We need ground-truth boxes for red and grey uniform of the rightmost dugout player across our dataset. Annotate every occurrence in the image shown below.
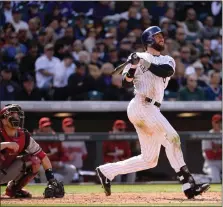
[202,129,222,183]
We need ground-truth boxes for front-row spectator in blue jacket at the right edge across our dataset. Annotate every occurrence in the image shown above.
[205,71,222,101]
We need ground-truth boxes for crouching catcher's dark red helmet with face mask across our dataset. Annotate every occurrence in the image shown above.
[0,104,25,128]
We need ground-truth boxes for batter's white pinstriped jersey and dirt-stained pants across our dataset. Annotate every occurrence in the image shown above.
[99,52,185,180]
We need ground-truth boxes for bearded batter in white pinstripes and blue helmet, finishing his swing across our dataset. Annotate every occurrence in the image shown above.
[96,26,210,199]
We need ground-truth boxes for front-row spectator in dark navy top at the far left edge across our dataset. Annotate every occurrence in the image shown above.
[0,64,20,101]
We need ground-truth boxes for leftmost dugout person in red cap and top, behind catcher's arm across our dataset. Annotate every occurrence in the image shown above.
[35,117,76,184]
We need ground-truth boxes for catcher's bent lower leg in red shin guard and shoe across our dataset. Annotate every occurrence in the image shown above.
[6,155,41,198]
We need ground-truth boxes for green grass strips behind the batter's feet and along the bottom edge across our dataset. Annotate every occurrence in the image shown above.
[0,184,222,206]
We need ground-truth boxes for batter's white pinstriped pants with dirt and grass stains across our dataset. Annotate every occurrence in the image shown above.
[99,95,185,180]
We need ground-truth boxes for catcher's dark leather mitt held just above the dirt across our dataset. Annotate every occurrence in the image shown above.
[43,179,65,198]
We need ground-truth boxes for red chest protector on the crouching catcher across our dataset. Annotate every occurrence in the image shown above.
[0,129,26,169]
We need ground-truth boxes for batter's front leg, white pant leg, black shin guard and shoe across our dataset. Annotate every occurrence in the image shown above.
[151,111,209,198]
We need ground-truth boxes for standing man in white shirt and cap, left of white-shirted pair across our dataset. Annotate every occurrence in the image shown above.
[35,44,60,90]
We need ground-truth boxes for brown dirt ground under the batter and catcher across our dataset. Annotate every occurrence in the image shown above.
[1,192,221,206]
